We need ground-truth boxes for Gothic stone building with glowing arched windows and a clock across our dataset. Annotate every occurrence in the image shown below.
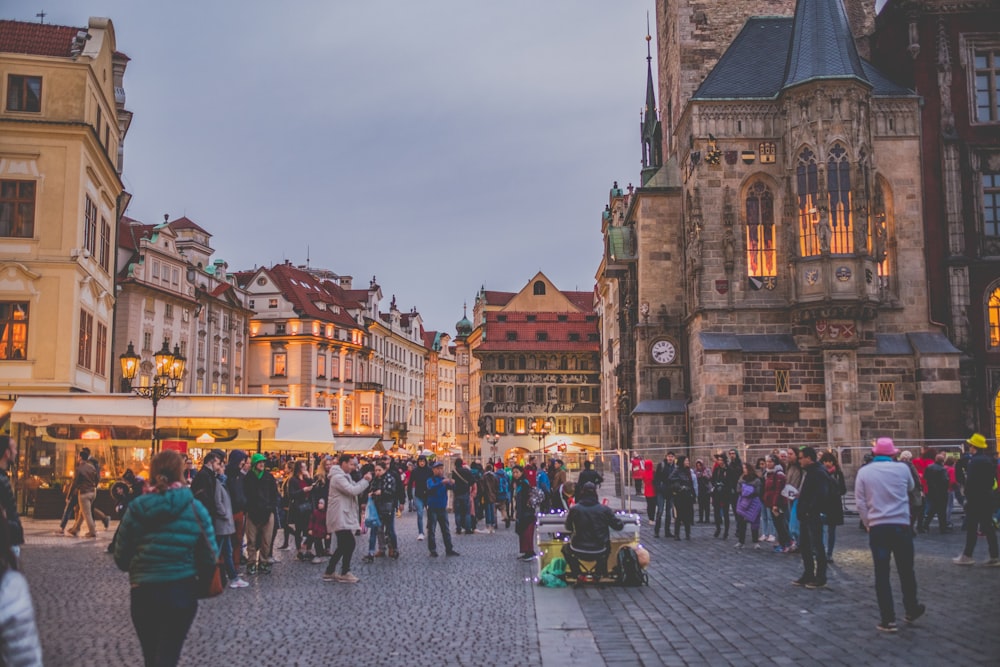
[599,0,964,463]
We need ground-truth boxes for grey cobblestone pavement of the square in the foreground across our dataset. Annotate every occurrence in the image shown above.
[15,500,1000,667]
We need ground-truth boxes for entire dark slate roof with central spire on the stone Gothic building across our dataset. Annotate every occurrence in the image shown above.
[692,7,916,100]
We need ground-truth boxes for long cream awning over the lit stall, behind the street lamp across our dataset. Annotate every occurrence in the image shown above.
[11,394,279,438]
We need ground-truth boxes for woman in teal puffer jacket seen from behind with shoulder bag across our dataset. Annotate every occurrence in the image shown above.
[115,450,218,667]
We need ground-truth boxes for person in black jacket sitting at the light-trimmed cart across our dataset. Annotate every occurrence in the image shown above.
[562,482,625,579]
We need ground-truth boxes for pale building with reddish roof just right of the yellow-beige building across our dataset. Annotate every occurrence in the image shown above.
[113,216,252,394]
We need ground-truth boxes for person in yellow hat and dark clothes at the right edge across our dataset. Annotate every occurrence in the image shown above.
[952,433,1000,567]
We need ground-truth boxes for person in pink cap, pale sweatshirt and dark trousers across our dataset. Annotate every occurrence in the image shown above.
[856,438,926,632]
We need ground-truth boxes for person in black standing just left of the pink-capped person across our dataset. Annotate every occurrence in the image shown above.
[792,447,832,589]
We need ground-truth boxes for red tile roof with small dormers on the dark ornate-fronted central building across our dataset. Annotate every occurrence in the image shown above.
[476,311,601,353]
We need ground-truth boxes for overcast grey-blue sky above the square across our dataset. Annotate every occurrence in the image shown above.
[15,0,656,332]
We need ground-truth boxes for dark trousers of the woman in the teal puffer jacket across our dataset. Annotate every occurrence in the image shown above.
[131,577,198,667]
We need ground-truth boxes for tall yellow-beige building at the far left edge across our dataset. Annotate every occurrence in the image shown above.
[0,18,131,397]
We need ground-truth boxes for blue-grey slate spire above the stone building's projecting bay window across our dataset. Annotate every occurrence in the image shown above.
[784,0,869,88]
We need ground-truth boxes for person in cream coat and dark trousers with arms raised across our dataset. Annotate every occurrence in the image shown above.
[323,454,372,584]
